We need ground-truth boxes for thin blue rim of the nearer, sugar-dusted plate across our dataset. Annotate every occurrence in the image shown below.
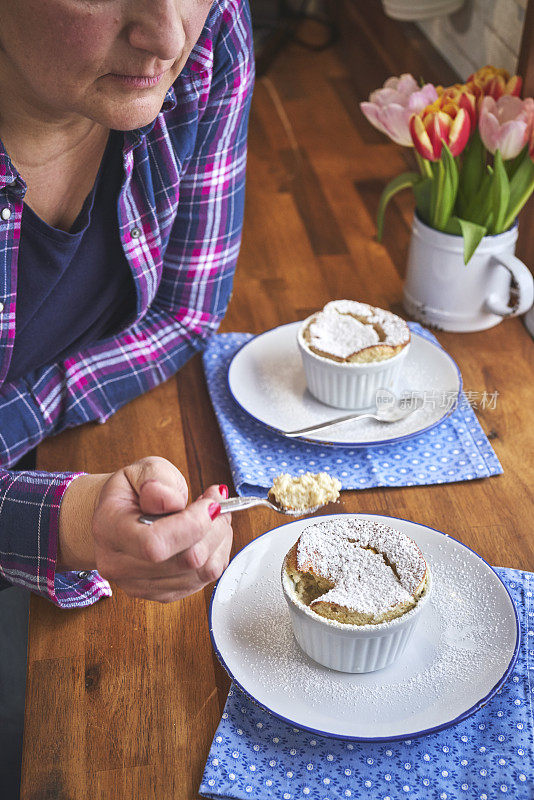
[208,512,521,743]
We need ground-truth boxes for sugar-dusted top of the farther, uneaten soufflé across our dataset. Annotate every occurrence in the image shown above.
[308,300,410,359]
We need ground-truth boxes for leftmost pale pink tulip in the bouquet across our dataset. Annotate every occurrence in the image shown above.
[360,72,438,147]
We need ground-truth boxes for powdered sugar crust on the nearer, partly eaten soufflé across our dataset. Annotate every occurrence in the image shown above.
[297,518,427,621]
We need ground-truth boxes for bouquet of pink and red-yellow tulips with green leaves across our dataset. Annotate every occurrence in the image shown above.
[360,66,534,264]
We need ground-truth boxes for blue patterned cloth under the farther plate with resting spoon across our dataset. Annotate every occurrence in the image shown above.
[203,323,502,495]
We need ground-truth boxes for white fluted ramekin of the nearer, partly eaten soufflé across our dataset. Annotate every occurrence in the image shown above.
[282,565,432,672]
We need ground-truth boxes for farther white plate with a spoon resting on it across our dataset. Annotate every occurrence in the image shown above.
[228,322,462,447]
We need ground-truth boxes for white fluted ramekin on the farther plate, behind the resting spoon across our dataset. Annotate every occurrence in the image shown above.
[297,314,410,408]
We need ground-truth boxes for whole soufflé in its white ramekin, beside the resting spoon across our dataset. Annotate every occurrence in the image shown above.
[297,300,410,408]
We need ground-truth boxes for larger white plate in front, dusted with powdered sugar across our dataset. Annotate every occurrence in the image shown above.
[210,514,520,741]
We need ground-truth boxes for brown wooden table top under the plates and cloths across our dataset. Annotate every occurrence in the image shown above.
[21,4,534,800]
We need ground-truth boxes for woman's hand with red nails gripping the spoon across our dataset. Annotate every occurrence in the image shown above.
[56,457,232,602]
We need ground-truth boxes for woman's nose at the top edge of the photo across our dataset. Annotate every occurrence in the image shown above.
[127,0,186,61]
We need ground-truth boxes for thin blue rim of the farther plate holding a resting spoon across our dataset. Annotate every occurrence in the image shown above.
[226,321,463,447]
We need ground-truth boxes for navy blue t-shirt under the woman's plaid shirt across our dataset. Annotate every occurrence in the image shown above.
[6,131,136,380]
